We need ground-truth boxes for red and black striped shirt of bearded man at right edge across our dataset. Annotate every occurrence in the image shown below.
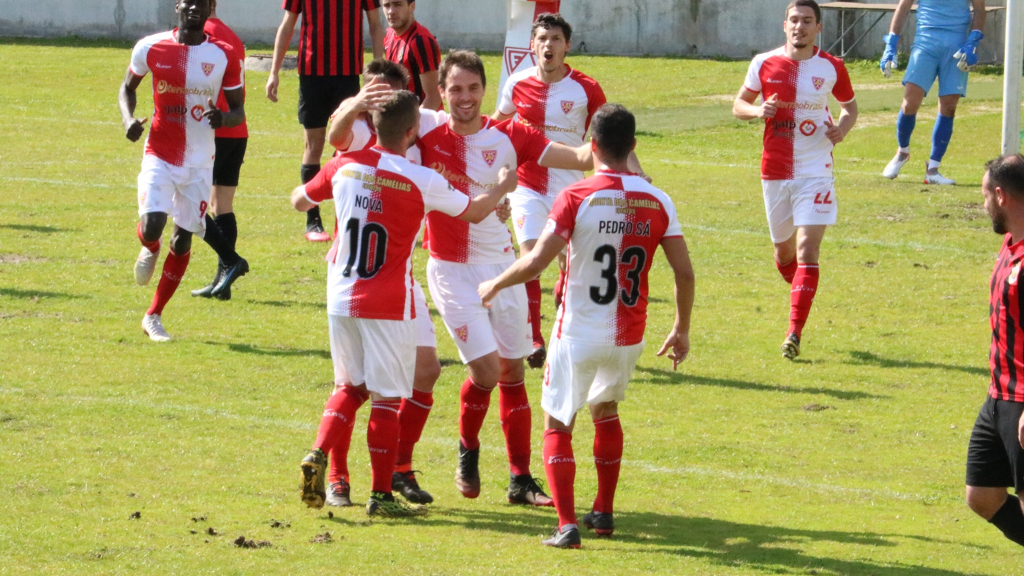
[988,234,1024,402]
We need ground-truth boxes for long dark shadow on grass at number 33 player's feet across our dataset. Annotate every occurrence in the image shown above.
[415,508,977,576]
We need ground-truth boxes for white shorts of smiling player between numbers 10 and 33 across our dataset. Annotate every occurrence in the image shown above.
[427,258,534,364]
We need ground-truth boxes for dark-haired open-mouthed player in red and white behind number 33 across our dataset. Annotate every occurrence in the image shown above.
[492,13,606,368]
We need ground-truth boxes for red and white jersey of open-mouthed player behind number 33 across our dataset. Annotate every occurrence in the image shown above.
[498,66,607,196]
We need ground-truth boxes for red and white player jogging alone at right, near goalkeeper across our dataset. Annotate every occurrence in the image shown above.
[732,0,857,360]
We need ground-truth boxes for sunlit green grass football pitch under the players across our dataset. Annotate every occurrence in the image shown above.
[0,40,1024,576]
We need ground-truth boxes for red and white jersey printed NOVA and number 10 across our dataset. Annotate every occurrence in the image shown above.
[305,147,469,320]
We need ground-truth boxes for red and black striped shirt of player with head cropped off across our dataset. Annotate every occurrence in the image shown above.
[282,0,381,76]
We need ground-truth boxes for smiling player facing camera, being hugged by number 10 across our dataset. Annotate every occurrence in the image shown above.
[418,50,593,505]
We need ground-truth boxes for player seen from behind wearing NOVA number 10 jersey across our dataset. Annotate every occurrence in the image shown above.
[292,90,515,516]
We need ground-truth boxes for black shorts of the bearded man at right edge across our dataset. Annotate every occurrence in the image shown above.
[967,397,1024,487]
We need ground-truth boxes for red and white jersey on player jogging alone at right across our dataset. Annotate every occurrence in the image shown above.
[743,46,854,180]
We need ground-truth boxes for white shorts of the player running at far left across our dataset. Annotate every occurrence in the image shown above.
[138,154,213,238]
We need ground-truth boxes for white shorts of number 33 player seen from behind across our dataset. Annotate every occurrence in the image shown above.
[541,333,644,425]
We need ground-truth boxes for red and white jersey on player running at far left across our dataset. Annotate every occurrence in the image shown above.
[130,29,243,168]
